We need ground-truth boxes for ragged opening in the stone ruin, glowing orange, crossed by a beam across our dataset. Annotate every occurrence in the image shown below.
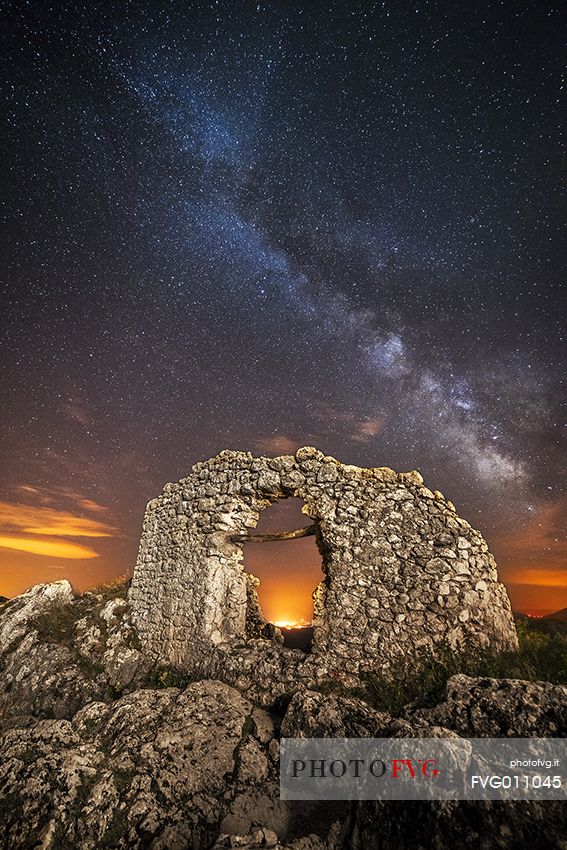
[243,497,324,652]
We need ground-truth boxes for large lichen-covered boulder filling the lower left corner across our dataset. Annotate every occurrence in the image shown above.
[0,682,287,850]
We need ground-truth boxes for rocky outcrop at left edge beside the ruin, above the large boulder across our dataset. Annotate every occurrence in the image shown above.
[0,581,149,728]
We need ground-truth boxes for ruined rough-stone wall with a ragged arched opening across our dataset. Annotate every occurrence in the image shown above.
[129,447,517,679]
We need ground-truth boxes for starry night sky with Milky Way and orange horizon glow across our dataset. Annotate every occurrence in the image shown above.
[0,0,567,619]
